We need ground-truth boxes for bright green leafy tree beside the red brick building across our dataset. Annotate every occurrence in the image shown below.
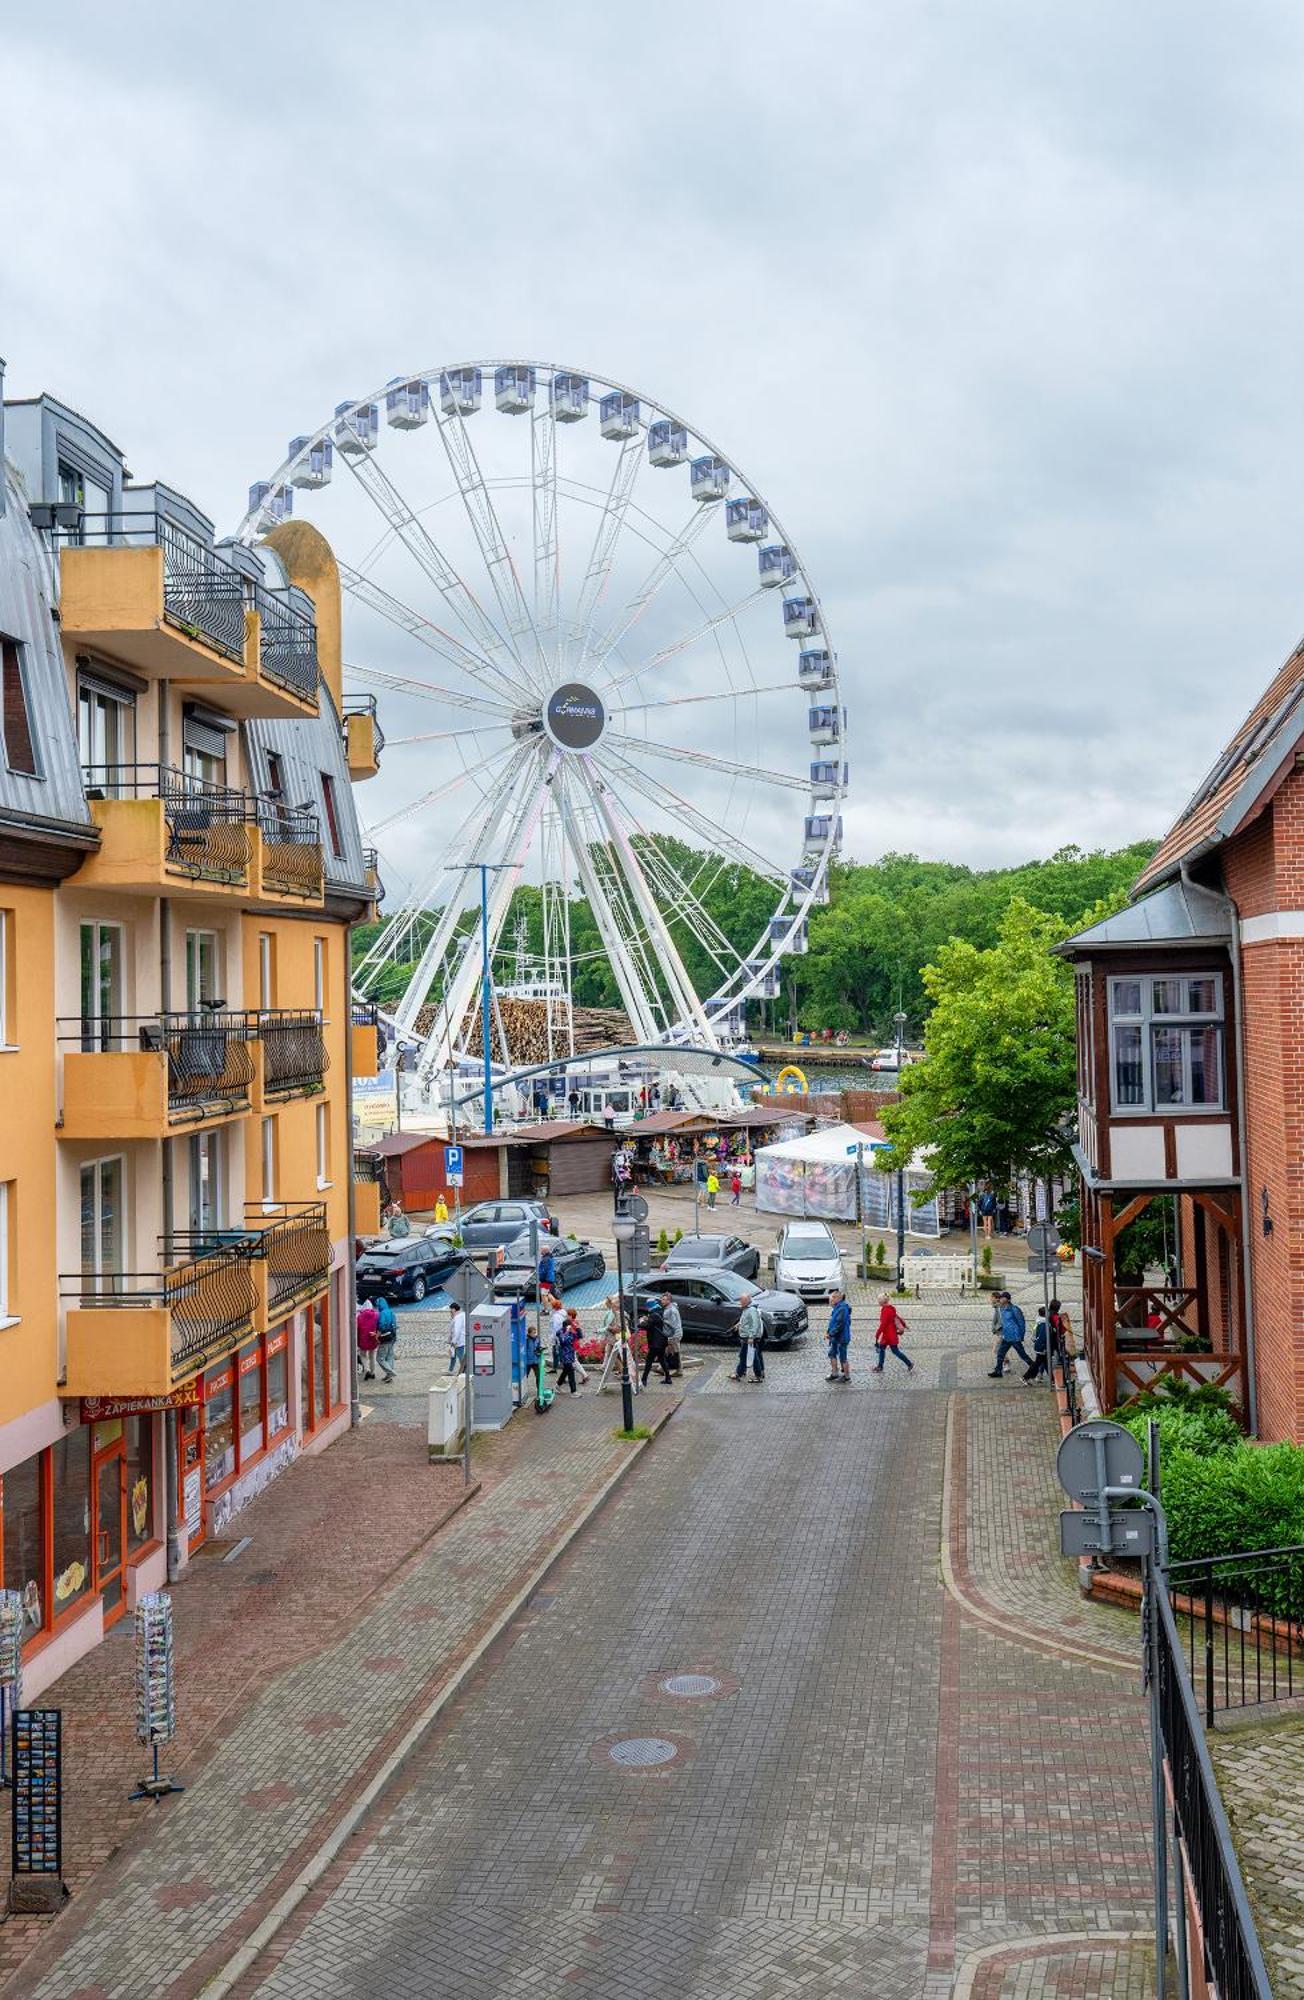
[884,896,1076,1188]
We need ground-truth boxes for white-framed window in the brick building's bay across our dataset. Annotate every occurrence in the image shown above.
[1108,972,1224,1112]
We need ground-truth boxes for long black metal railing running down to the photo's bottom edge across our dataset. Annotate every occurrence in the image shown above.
[1150,1590,1272,2000]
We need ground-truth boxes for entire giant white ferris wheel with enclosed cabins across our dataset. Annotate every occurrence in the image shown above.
[240,360,848,1096]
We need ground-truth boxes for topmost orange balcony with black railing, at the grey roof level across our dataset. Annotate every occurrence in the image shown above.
[54,512,318,718]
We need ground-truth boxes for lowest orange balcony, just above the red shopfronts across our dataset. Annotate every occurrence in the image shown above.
[60,1238,260,1396]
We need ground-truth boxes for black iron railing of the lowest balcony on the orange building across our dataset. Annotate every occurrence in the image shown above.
[58,1234,256,1376]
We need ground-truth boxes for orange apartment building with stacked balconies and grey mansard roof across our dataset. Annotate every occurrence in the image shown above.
[0,372,378,1694]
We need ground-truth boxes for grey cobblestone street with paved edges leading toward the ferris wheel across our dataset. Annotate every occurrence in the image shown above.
[0,1302,1148,2000]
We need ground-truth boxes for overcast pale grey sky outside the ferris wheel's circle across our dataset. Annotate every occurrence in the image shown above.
[0,0,1304,864]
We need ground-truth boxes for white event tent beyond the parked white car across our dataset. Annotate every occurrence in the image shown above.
[756,1124,942,1236]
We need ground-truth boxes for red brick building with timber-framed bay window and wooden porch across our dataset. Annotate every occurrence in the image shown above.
[1064,646,1304,1442]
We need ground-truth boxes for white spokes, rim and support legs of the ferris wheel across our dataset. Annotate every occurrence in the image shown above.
[236,358,846,1084]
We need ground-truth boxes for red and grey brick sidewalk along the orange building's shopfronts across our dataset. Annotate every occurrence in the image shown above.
[0,1384,680,2000]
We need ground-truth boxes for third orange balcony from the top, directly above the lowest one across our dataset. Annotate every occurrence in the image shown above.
[58,1010,258,1140]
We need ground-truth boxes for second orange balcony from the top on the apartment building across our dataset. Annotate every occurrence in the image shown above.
[76,764,258,896]
